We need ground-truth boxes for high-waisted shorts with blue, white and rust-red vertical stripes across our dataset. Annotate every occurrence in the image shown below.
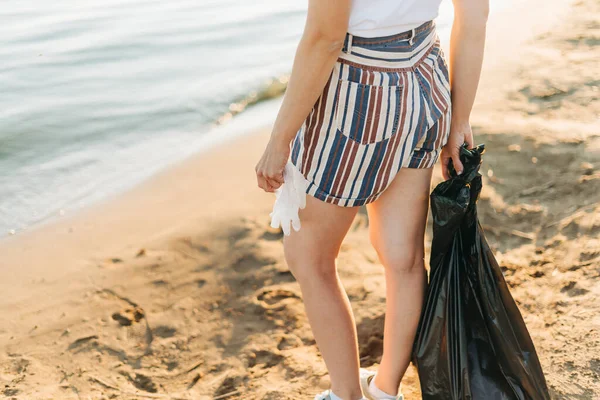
[290,21,451,207]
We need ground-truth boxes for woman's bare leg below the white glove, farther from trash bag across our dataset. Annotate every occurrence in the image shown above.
[283,196,362,400]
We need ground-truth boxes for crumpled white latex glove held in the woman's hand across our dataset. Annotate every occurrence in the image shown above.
[269,161,308,235]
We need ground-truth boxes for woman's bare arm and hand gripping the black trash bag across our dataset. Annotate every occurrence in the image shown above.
[442,0,489,179]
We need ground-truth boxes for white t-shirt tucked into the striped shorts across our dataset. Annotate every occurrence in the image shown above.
[348,0,442,37]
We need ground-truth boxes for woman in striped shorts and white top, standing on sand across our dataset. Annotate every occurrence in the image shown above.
[256,0,488,400]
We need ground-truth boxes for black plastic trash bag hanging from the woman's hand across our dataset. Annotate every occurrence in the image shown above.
[413,145,550,400]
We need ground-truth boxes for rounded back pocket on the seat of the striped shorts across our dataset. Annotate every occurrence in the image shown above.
[336,79,402,144]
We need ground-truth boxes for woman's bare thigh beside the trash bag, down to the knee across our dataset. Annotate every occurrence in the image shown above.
[367,168,432,268]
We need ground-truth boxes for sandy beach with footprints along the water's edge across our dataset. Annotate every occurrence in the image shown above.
[0,0,600,400]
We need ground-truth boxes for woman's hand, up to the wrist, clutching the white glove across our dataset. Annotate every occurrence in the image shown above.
[254,136,290,192]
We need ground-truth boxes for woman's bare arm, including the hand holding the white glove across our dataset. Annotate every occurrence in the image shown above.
[255,0,351,192]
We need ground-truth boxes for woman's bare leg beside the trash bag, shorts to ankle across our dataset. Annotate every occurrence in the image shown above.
[367,168,432,395]
